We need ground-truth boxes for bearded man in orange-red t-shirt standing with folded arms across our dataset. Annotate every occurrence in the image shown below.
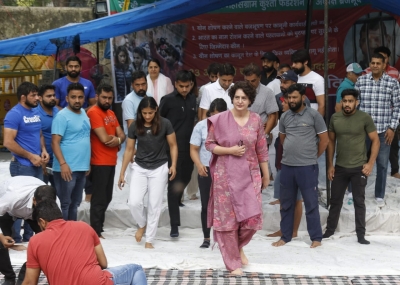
[87,84,125,238]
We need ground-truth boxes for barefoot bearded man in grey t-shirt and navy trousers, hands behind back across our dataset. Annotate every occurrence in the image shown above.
[272,84,329,248]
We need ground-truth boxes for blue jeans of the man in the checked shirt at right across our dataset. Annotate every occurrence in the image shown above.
[366,132,390,199]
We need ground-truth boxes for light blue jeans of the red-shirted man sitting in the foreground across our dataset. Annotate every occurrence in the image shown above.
[106,264,147,285]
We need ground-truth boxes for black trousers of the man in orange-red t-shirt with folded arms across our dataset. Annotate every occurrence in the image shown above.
[89,165,115,236]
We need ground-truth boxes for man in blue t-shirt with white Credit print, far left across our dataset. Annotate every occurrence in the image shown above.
[4,82,49,180]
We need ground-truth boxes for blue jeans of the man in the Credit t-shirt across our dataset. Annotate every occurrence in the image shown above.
[10,160,43,242]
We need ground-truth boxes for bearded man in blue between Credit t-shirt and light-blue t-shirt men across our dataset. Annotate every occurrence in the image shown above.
[37,84,58,188]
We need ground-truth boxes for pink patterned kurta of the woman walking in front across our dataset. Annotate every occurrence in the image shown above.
[205,111,268,231]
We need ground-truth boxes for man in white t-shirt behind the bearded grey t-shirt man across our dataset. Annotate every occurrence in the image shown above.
[292,49,325,117]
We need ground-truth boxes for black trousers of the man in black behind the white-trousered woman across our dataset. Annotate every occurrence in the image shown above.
[167,151,193,226]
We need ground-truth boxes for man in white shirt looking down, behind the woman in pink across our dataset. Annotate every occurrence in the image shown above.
[200,63,235,120]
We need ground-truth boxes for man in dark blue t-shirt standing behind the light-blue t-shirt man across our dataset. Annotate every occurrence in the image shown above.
[53,55,96,108]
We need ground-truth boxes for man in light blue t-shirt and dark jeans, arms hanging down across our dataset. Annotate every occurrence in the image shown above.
[51,83,90,221]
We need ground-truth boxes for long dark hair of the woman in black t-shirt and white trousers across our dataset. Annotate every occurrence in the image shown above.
[135,97,161,136]
